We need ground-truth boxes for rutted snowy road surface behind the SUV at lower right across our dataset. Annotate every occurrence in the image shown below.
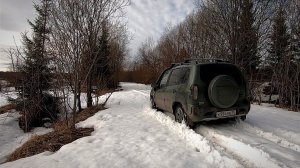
[195,106,300,167]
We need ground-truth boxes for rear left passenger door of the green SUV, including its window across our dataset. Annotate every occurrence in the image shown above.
[164,67,189,112]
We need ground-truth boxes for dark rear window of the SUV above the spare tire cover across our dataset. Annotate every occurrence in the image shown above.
[200,64,243,85]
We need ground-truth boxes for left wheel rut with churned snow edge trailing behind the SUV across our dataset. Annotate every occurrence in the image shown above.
[145,107,286,168]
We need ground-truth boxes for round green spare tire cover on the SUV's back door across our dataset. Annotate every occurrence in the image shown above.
[208,75,239,108]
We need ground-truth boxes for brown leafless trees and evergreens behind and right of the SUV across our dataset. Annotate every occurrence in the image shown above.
[125,0,300,109]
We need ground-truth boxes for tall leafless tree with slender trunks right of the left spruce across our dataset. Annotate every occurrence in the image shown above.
[51,0,128,126]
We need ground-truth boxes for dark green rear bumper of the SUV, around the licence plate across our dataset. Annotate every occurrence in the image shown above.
[187,101,250,122]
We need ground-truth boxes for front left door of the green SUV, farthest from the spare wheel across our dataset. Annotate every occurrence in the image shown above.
[154,70,171,110]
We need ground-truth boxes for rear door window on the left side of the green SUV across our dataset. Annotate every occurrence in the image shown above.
[168,68,190,85]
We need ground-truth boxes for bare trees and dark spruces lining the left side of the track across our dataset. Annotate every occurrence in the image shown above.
[8,0,129,131]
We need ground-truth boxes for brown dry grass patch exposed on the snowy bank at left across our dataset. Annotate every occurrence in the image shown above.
[7,106,104,162]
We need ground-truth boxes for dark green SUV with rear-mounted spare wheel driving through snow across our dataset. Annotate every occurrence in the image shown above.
[150,59,250,127]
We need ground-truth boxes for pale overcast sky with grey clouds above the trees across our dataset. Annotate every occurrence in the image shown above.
[0,0,195,70]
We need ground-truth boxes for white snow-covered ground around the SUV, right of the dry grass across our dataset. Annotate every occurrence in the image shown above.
[0,83,300,168]
